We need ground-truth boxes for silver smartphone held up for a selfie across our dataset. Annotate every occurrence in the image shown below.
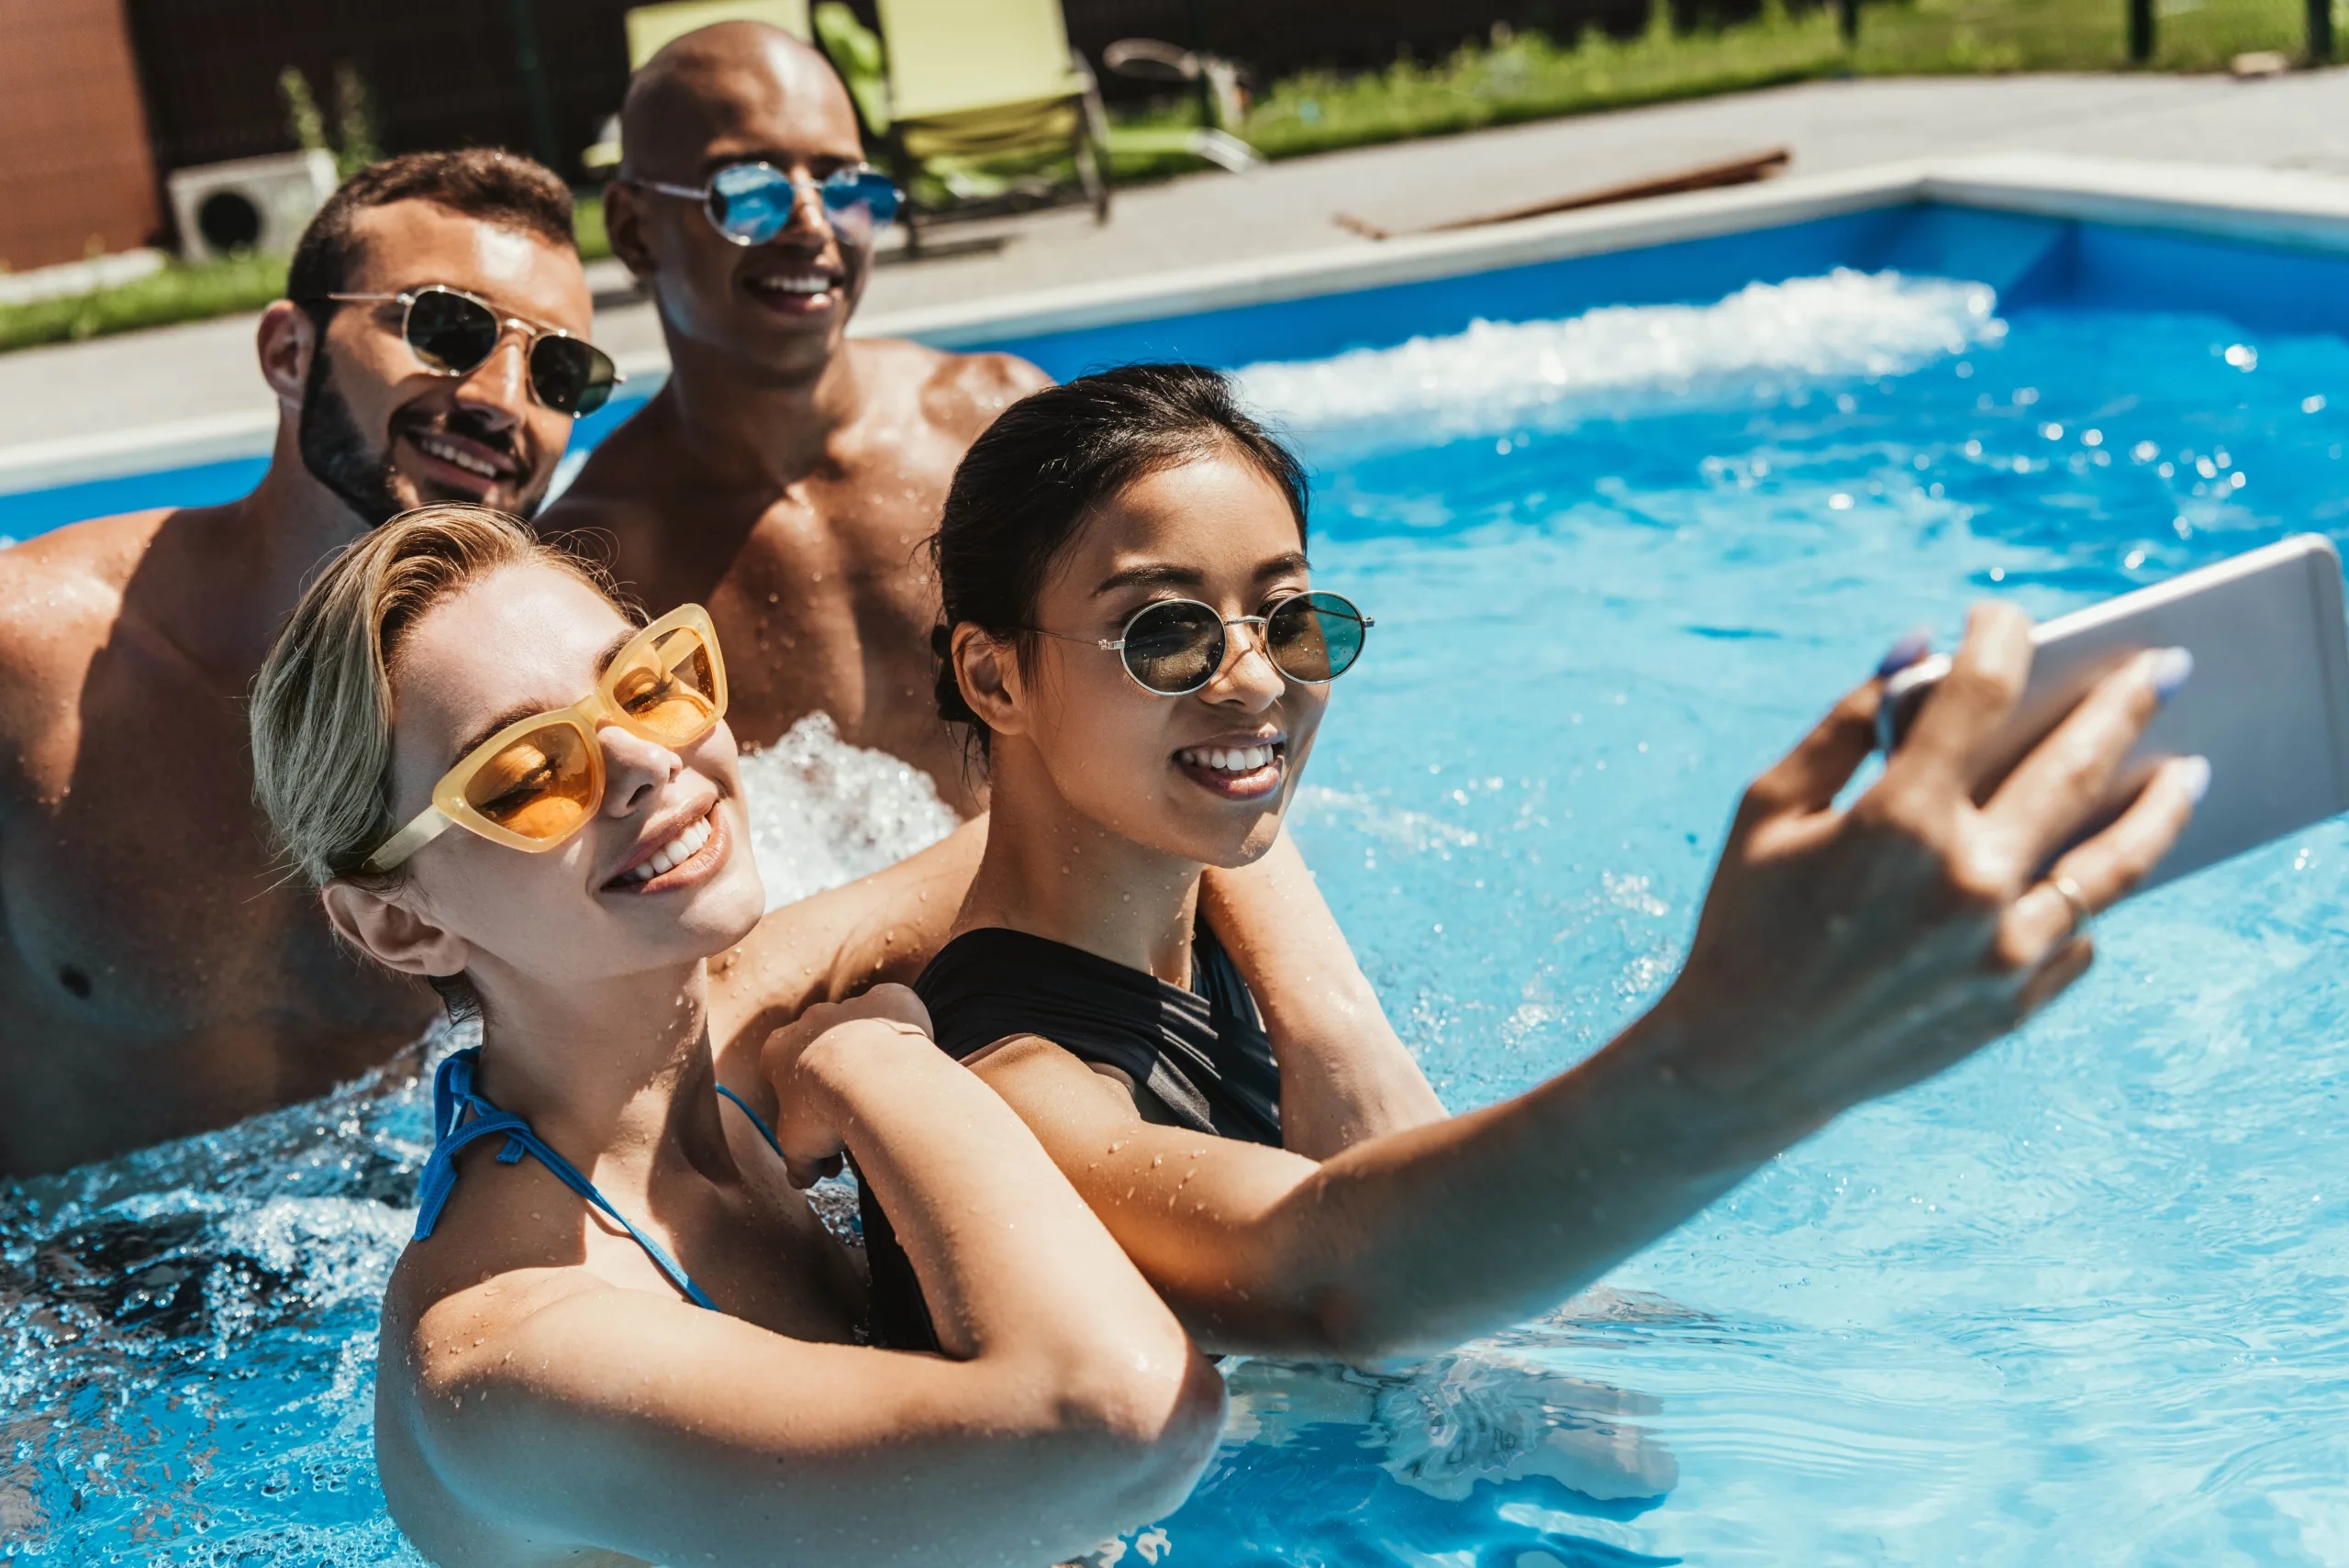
[1876,533,2349,887]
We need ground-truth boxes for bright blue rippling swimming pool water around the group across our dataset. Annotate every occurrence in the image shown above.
[0,199,2349,1568]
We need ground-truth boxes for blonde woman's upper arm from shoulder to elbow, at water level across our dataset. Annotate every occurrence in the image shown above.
[427,1286,1221,1568]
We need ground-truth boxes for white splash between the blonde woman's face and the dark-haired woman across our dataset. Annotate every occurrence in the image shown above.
[742,714,958,908]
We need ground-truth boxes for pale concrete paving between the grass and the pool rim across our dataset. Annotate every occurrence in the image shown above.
[0,68,2349,474]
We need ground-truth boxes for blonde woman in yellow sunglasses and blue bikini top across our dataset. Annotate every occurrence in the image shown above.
[251,507,1221,1565]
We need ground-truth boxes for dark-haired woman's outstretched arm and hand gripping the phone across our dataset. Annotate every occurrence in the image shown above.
[958,610,2197,1362]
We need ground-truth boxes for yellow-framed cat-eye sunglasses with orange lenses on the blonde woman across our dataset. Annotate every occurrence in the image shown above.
[360,604,726,875]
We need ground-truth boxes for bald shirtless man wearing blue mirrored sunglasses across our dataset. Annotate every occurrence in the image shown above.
[540,21,1045,815]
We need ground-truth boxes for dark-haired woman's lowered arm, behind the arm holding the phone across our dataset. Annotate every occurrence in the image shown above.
[1200,833,1444,1160]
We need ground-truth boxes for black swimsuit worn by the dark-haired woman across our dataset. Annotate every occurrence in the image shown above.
[863,920,1280,1350]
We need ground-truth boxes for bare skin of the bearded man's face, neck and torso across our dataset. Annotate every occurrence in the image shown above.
[0,202,590,1173]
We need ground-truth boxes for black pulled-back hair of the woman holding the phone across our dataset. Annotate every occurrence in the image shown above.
[930,364,1306,756]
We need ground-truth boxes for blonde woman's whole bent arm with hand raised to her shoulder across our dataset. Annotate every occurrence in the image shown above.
[385,991,1221,1568]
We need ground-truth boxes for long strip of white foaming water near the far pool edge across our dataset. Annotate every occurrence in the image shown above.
[1238,268,2006,446]
